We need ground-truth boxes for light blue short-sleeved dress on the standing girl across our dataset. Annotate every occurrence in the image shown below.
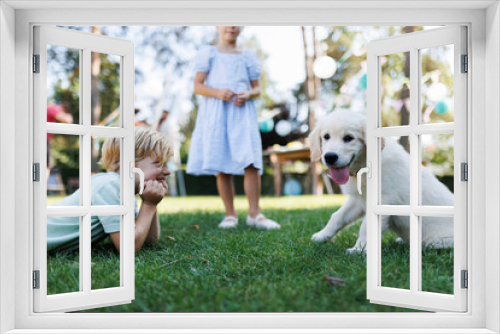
[186,45,262,175]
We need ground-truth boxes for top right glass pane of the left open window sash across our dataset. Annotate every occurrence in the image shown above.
[91,52,121,126]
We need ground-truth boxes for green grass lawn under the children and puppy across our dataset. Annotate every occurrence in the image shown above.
[48,195,453,312]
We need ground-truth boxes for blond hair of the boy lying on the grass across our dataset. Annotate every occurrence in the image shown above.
[102,127,172,172]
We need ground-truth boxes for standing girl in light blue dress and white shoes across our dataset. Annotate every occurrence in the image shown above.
[187,26,281,230]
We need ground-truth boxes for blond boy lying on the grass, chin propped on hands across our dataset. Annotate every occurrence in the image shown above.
[47,127,172,252]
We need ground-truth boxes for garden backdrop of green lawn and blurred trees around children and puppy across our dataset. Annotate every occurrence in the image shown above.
[47,26,453,312]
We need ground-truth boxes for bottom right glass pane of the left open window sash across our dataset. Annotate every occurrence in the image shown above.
[91,215,121,290]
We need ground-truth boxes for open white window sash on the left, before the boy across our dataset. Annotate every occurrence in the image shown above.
[33,26,135,313]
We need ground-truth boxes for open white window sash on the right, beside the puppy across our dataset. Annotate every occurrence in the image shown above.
[366,26,473,312]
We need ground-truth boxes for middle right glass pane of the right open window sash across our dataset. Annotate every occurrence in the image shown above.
[420,133,455,206]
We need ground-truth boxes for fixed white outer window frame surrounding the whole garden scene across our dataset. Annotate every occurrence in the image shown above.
[0,1,500,333]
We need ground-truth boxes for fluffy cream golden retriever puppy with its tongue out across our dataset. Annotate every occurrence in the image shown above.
[309,110,453,253]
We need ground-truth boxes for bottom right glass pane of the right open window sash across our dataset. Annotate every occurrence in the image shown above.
[421,217,454,294]
